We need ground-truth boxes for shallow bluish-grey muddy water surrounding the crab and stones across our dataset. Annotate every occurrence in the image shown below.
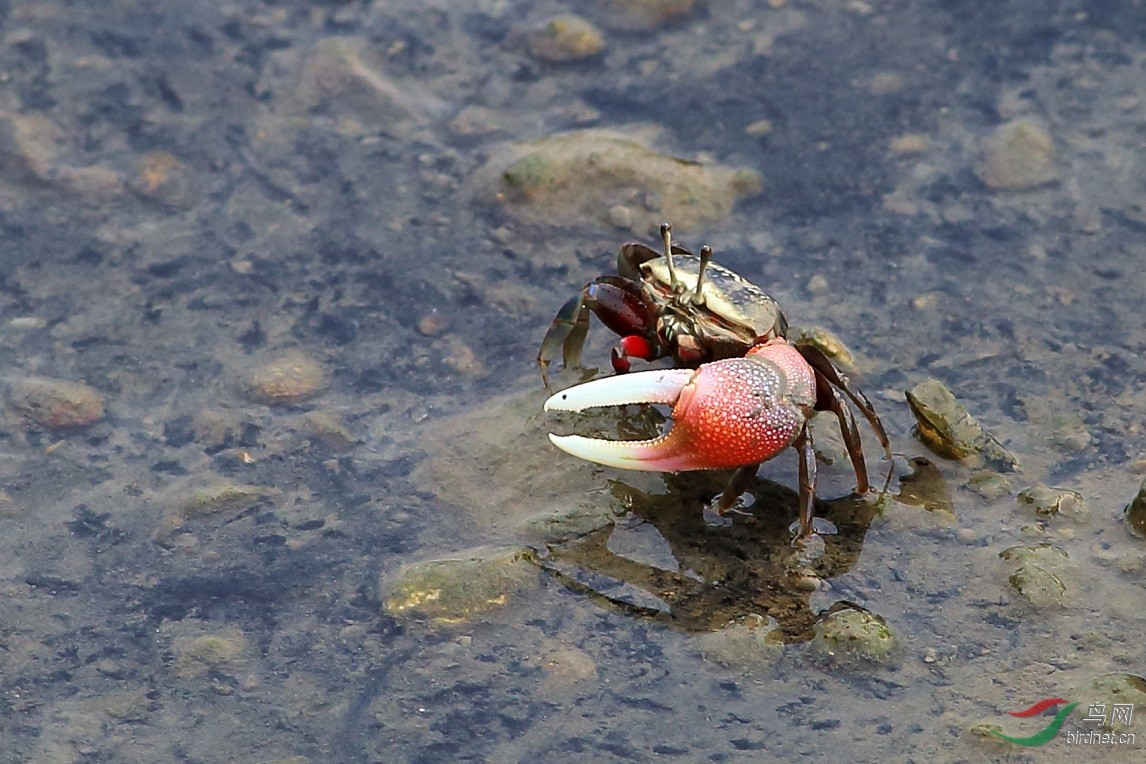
[0,0,1146,762]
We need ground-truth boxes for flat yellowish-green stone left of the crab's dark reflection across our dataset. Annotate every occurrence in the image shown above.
[378,548,540,623]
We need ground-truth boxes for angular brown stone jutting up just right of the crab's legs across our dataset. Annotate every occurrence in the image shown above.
[906,379,1018,471]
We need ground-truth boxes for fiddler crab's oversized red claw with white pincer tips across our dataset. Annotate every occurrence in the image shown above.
[545,357,804,472]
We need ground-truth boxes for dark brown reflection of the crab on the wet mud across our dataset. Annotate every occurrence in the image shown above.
[542,472,879,644]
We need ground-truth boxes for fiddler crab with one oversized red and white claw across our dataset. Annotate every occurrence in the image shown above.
[537,223,892,538]
